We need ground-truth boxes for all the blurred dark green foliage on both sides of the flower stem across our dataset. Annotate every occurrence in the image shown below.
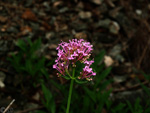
[8,39,150,113]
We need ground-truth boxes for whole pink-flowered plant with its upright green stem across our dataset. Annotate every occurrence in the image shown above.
[53,39,96,113]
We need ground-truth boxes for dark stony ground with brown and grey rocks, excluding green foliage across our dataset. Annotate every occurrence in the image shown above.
[0,0,150,112]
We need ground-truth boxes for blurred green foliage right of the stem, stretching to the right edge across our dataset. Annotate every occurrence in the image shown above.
[57,50,150,113]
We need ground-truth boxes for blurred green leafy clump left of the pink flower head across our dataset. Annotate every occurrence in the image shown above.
[8,38,48,85]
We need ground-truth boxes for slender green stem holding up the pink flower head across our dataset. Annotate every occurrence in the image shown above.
[66,68,75,113]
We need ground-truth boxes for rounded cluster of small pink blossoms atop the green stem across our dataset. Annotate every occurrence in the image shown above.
[53,39,96,80]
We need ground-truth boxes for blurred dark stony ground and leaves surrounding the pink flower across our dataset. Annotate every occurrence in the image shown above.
[0,0,150,113]
